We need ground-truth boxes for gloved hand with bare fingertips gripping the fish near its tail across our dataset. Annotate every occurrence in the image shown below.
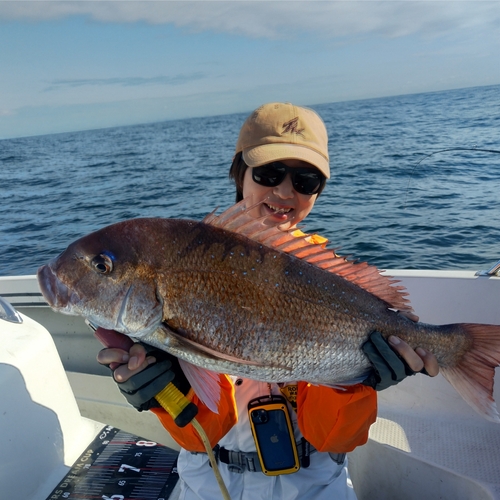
[362,332,439,391]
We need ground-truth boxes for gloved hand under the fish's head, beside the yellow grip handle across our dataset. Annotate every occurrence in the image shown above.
[96,328,190,411]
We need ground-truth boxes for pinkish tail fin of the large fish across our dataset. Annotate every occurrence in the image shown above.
[440,323,500,423]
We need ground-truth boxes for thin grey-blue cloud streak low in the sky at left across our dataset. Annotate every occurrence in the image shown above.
[45,71,205,91]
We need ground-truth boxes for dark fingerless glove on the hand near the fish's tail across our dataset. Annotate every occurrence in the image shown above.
[361,332,425,391]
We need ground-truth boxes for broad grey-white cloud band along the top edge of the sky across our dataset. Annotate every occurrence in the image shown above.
[0,0,500,39]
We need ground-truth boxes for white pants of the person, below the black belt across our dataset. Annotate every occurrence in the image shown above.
[174,450,356,500]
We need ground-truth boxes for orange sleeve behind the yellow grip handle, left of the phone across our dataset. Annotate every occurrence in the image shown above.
[151,375,238,452]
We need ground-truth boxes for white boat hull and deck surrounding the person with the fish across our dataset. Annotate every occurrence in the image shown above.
[0,261,500,500]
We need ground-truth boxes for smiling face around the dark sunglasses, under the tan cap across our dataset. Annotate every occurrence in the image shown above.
[243,160,318,231]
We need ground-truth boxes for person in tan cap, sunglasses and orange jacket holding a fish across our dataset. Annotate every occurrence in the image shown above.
[98,103,439,500]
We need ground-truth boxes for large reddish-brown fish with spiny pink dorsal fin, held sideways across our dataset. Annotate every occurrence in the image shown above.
[38,202,500,421]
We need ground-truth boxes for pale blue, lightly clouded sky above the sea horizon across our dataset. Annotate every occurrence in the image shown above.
[0,0,500,139]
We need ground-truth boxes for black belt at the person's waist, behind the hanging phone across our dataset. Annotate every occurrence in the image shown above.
[214,439,346,474]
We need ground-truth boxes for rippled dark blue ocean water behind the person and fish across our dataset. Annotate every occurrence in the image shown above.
[0,85,500,276]
